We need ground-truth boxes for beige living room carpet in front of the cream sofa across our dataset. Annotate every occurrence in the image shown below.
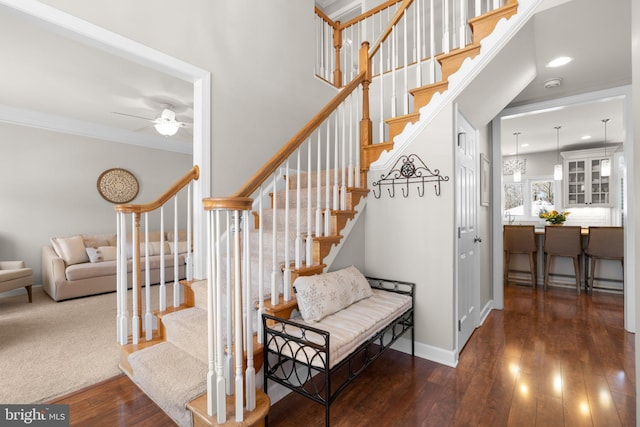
[0,287,170,404]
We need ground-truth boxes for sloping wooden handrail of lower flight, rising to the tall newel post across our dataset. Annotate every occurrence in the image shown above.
[228,72,365,201]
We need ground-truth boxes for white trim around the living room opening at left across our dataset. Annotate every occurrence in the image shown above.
[0,0,212,277]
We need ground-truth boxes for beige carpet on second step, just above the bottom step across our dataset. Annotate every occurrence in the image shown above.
[162,307,208,363]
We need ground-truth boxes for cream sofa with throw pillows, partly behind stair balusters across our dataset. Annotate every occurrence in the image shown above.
[42,231,187,301]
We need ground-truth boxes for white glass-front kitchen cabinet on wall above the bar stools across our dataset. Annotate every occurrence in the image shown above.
[562,149,614,208]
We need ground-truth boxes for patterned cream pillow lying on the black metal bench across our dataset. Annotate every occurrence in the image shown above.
[293,266,373,322]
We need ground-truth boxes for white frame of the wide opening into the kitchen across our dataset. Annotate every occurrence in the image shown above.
[491,85,636,333]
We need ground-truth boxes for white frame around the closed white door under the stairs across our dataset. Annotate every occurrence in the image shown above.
[453,103,481,363]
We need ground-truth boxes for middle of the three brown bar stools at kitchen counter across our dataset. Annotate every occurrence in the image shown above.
[544,225,582,295]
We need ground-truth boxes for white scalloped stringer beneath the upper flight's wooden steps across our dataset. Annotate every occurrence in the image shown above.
[370,0,545,171]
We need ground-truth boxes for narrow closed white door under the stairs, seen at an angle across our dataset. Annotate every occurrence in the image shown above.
[456,112,480,353]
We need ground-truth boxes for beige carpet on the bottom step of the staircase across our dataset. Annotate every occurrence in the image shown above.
[129,342,207,426]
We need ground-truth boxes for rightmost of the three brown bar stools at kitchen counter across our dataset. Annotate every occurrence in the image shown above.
[585,227,624,295]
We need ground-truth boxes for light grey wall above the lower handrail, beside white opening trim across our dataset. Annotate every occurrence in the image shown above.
[36,0,336,196]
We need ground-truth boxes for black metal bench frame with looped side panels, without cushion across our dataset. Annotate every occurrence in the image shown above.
[262,277,415,426]
